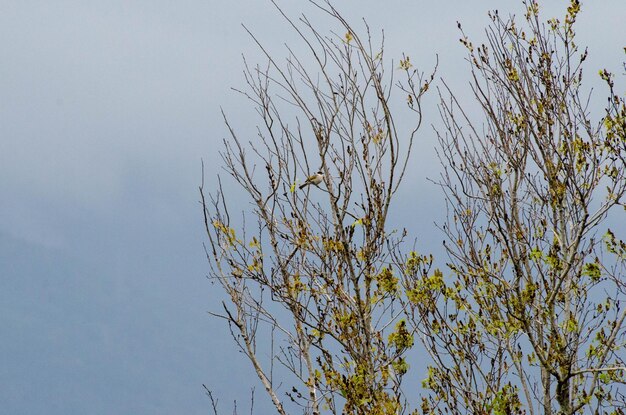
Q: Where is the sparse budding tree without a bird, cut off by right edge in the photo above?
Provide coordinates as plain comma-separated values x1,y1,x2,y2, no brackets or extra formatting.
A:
405,0,626,414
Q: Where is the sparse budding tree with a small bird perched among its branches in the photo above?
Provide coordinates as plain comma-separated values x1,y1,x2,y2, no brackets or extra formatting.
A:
200,2,434,414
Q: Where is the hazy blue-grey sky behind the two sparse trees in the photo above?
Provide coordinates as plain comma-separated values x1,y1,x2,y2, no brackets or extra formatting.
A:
0,0,626,415
